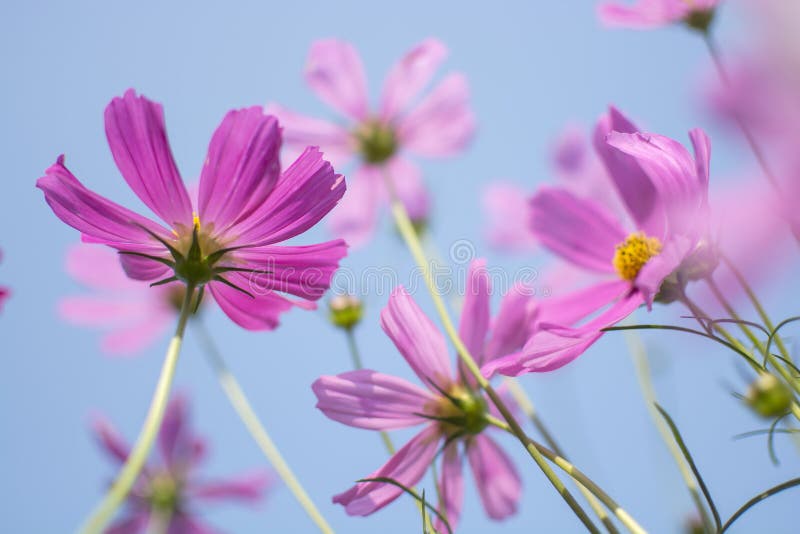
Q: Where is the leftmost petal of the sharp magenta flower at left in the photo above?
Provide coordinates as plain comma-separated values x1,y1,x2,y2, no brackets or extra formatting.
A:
36,156,170,250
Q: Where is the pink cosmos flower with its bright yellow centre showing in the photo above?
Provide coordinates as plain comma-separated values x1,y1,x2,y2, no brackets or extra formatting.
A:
483,108,715,375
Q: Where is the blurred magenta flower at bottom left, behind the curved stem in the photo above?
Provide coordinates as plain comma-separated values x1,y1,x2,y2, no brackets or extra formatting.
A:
93,396,271,534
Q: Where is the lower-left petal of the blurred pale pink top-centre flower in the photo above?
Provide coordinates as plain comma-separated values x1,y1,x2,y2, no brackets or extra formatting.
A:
330,165,386,247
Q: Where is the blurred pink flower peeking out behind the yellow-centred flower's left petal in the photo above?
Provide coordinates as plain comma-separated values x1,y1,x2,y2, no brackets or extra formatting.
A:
483,126,619,252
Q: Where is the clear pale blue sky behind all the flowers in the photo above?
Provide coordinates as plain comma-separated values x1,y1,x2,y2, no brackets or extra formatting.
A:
0,0,800,533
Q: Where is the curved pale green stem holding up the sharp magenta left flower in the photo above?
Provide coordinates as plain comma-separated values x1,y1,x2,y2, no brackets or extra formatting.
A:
80,284,195,534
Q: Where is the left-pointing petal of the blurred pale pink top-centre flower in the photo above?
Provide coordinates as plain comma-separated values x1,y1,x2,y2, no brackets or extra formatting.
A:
264,104,356,167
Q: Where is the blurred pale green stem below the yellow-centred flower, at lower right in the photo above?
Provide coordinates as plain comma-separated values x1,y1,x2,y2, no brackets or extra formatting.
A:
624,322,715,532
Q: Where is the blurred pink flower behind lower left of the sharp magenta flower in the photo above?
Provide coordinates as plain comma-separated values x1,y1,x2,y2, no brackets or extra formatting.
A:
58,244,200,356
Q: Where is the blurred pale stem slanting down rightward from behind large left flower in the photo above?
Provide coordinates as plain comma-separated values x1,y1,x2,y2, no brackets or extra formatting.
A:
196,318,333,534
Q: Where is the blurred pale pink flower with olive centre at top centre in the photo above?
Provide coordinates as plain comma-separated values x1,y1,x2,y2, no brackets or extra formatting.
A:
267,39,475,245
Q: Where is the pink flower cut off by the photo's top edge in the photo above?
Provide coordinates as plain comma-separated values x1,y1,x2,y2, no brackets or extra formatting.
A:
597,0,721,30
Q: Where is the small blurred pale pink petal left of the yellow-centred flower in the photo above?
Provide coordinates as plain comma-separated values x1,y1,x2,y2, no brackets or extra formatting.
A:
482,182,536,252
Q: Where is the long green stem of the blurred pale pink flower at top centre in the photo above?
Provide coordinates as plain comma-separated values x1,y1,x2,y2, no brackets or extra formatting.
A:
385,175,608,532
